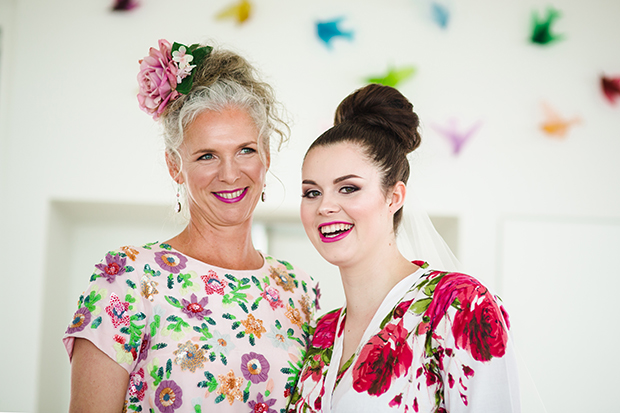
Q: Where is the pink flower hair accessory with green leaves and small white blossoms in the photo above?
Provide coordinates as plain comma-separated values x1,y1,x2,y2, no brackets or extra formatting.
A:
138,39,213,120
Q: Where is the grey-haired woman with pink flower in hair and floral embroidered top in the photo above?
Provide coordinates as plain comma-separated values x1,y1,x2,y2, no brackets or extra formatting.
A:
63,40,316,413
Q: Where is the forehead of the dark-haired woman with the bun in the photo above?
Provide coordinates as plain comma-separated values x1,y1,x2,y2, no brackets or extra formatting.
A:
302,142,379,181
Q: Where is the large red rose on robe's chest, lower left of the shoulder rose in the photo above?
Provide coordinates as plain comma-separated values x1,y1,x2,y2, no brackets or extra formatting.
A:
353,320,413,396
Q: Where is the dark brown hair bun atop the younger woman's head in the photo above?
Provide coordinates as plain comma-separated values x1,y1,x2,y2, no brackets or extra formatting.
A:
334,83,421,153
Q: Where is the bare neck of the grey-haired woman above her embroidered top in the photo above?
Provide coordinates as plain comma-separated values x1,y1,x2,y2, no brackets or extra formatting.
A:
167,216,263,270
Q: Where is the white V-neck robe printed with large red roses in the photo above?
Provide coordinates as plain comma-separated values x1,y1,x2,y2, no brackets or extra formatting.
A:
289,261,520,413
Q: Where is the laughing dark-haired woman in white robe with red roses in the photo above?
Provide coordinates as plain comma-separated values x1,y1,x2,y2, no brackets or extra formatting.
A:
290,84,519,413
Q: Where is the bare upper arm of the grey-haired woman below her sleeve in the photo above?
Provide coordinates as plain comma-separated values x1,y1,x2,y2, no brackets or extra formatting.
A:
69,338,129,413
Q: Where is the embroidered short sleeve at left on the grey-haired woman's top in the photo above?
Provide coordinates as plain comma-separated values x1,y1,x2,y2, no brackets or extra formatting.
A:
63,250,147,373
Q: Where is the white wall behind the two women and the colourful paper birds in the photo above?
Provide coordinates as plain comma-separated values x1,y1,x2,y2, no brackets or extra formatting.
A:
0,0,620,412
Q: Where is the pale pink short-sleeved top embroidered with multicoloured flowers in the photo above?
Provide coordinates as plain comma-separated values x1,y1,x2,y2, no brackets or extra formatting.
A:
63,243,317,413
